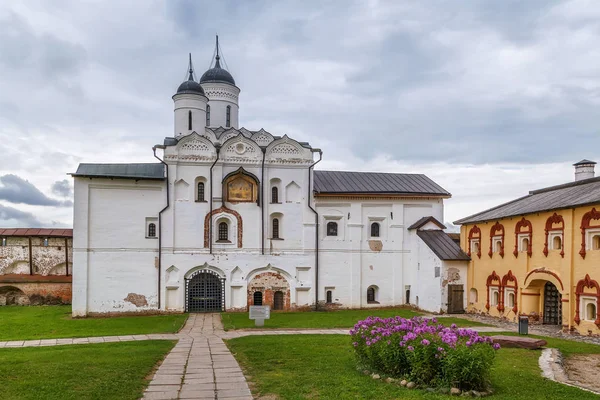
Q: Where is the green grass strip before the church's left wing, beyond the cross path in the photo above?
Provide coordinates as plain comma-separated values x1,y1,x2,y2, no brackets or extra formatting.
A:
0,306,187,340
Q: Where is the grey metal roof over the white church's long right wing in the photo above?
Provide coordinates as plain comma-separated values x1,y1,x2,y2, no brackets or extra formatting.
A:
314,171,451,197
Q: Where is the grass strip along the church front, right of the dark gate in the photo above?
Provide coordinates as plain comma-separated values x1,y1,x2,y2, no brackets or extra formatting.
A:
221,308,487,331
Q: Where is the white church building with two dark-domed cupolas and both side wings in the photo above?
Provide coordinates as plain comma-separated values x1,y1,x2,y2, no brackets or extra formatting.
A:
72,39,469,316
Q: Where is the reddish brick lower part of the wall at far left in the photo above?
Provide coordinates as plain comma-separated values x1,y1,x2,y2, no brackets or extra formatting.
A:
0,274,72,306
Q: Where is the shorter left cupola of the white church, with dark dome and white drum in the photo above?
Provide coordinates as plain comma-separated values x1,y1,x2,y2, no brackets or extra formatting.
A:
173,54,208,137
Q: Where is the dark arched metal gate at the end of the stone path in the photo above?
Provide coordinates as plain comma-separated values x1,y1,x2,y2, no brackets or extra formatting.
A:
185,269,225,312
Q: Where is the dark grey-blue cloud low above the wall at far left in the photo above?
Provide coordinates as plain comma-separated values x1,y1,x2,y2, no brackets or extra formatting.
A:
0,174,73,207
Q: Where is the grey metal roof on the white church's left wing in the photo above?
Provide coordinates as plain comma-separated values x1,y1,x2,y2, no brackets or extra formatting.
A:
71,163,165,180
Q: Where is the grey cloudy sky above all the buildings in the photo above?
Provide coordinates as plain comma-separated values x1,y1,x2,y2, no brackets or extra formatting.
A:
0,0,600,227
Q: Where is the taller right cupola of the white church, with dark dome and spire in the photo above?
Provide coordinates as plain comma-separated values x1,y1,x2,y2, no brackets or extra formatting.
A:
200,36,240,128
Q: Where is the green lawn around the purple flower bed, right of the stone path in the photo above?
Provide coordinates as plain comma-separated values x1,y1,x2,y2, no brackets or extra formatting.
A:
227,335,600,400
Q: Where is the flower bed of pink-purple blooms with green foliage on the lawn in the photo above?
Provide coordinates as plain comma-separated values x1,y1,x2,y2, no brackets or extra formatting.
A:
350,317,500,390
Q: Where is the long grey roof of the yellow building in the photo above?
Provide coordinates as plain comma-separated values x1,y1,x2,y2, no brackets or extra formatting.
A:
454,177,600,224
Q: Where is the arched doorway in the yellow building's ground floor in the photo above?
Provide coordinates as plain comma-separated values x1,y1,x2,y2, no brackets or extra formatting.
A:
521,268,565,325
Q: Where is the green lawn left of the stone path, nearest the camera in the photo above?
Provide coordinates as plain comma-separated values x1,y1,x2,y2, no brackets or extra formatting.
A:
0,340,174,400
